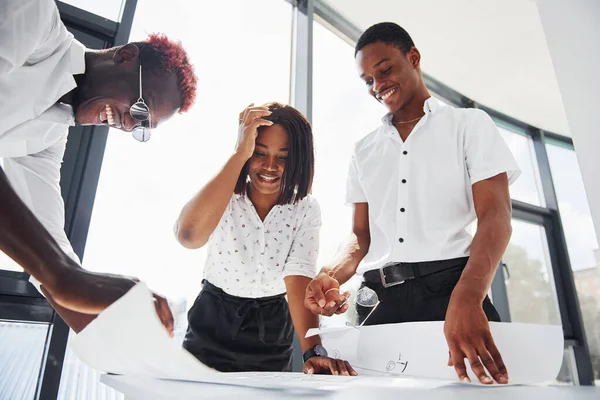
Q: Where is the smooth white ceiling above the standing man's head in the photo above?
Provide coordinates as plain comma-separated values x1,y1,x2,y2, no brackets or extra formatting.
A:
325,0,570,136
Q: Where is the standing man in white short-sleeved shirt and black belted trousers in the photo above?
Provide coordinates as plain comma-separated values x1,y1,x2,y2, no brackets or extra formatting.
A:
305,23,519,384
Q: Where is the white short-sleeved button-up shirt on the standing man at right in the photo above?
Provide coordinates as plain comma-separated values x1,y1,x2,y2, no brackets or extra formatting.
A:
346,97,520,274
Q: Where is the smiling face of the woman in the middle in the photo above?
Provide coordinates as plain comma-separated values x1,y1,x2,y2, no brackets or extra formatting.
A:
248,124,288,199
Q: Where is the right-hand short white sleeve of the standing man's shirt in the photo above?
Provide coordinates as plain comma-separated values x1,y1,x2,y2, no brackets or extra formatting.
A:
465,110,521,185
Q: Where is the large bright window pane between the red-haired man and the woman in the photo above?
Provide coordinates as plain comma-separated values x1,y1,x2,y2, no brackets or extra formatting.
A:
61,0,292,393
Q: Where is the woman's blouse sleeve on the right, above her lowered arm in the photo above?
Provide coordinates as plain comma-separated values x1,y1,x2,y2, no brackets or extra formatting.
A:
283,197,321,278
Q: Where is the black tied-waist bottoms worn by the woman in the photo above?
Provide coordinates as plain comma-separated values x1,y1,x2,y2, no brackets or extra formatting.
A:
183,281,294,372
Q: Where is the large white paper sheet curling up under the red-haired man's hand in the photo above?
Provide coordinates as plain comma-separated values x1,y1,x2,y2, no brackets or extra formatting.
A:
70,283,445,394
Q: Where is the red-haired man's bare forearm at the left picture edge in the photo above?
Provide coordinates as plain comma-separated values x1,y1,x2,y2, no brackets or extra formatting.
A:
0,168,77,290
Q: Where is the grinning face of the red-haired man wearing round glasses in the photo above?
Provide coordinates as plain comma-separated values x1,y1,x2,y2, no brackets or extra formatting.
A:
73,45,181,132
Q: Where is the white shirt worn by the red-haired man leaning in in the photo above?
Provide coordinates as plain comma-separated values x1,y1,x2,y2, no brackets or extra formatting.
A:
0,0,85,262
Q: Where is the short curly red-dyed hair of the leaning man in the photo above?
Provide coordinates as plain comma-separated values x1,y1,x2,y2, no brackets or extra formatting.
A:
134,33,198,113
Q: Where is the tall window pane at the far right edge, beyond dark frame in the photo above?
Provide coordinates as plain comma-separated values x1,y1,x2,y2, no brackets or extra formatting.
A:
546,144,600,380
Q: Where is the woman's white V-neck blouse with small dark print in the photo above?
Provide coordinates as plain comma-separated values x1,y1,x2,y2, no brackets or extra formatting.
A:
204,194,321,298
